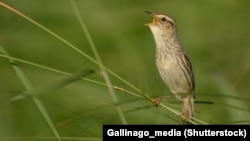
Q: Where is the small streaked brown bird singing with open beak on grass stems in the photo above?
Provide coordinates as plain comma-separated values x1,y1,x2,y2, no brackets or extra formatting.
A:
145,11,195,124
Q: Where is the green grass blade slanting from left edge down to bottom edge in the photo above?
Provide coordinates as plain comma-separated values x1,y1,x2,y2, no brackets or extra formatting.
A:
0,46,61,141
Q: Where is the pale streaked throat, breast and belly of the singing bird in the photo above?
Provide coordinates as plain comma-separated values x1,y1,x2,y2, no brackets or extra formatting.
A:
150,26,194,100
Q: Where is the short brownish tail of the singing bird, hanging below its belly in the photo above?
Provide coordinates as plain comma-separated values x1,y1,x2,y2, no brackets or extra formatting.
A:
182,95,194,122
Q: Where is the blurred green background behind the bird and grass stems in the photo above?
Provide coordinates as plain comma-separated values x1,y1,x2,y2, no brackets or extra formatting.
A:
0,0,250,140
